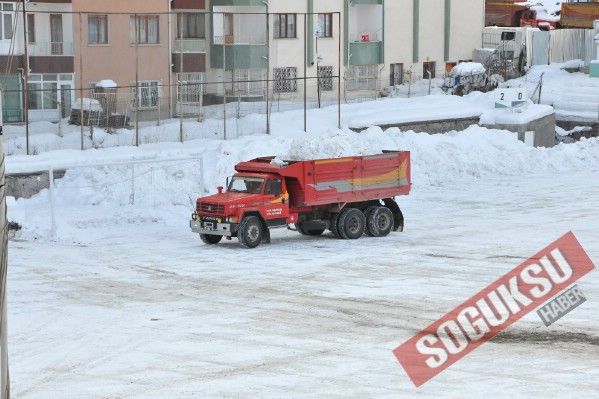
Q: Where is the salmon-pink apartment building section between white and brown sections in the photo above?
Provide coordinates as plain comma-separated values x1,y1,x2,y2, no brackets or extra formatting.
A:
73,0,171,119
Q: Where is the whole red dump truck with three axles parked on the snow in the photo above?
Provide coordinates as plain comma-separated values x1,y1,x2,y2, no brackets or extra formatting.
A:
190,151,411,248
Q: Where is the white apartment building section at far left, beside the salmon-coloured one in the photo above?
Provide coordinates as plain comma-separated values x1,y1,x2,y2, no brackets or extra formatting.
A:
0,0,74,122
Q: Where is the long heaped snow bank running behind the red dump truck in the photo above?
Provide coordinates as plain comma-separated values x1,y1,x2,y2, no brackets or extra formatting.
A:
8,126,599,242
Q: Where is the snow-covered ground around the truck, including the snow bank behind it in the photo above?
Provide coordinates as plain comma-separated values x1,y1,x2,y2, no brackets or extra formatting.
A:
7,121,599,399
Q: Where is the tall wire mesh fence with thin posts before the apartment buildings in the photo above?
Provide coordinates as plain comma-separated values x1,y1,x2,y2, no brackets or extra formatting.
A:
0,6,460,154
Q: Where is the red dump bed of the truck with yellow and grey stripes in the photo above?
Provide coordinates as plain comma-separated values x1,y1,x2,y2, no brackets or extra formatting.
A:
235,151,411,207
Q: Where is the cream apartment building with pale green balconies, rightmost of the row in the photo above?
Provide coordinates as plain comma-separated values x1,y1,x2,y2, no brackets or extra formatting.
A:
207,0,484,100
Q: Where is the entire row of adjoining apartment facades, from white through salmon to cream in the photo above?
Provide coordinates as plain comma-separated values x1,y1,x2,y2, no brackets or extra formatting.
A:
0,0,485,121
